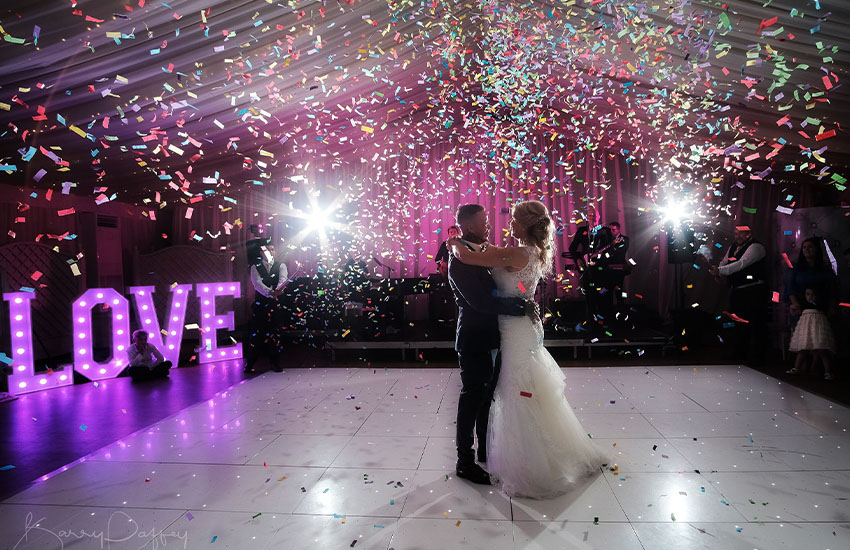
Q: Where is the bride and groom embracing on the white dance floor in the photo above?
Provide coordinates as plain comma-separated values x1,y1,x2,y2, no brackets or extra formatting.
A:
448,201,608,498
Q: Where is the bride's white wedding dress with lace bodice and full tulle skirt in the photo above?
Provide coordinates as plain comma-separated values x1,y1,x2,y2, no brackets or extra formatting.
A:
487,253,609,498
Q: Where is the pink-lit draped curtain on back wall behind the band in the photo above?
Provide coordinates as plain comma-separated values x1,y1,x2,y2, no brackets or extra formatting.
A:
166,139,716,320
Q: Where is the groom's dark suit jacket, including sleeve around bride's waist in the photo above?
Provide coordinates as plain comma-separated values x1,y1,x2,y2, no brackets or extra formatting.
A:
449,243,525,352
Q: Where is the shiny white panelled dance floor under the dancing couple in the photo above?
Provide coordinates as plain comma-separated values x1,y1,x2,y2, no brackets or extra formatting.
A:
0,366,850,550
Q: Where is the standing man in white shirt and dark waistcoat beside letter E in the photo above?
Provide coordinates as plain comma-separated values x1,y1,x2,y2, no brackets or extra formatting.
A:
245,244,289,372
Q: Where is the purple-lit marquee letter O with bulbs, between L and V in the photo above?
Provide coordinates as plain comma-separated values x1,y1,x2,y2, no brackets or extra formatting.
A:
71,288,130,380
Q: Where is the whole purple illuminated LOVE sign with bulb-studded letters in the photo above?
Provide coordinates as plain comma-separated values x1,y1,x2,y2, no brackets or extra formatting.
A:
3,282,242,395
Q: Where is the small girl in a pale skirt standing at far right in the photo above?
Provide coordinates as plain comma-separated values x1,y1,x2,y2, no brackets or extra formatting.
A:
786,288,835,380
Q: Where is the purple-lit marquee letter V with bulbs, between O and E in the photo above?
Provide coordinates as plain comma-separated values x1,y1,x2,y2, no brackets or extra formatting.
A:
130,285,192,365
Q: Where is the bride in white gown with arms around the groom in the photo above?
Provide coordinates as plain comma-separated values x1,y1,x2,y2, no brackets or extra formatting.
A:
450,201,609,498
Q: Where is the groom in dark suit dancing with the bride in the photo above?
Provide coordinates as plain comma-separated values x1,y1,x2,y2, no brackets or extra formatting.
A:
449,204,537,485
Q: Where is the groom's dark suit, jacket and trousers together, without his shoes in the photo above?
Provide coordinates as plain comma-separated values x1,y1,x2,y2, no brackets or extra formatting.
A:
449,255,525,465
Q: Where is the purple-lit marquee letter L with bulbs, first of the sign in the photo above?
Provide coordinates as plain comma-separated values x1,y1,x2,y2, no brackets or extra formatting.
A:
3,292,74,395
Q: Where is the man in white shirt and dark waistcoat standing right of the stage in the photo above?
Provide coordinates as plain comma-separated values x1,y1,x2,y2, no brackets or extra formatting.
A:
708,225,769,366
